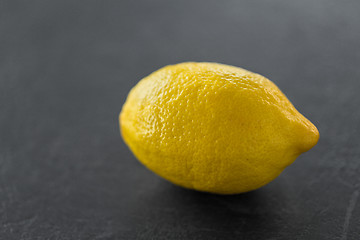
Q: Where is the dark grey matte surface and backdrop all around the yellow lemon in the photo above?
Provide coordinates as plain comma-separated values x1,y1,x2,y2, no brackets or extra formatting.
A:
0,0,360,240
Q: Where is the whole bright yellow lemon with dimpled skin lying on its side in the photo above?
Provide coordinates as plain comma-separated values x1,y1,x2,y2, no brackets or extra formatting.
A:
119,62,319,194
